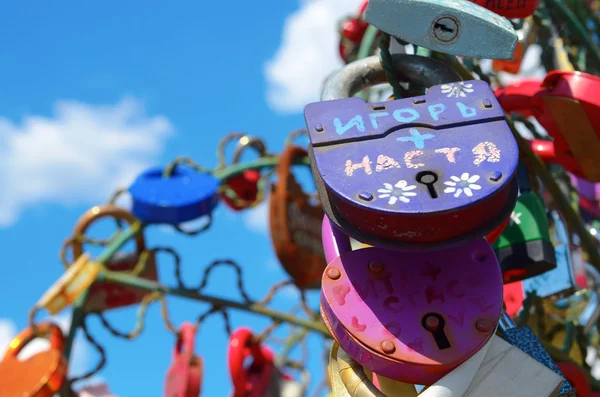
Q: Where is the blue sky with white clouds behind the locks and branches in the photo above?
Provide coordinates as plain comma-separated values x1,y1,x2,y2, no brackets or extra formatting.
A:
0,0,360,397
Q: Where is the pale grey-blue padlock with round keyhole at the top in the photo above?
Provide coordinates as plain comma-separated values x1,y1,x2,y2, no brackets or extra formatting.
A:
365,0,518,59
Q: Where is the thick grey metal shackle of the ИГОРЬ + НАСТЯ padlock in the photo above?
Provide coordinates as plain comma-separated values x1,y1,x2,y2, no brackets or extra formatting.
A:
321,54,462,101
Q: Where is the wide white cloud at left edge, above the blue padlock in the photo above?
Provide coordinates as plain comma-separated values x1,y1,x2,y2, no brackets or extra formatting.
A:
0,97,173,227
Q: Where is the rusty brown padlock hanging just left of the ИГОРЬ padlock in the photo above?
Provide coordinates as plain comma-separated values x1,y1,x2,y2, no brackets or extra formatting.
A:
269,146,327,289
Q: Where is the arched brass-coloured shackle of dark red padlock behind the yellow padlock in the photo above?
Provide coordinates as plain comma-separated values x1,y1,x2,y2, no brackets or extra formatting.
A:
71,204,146,260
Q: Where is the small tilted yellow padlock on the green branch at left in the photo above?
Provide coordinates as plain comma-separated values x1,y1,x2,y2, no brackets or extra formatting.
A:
36,253,102,315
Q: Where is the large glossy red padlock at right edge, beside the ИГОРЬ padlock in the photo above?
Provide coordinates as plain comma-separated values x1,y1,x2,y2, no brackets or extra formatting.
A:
496,70,600,182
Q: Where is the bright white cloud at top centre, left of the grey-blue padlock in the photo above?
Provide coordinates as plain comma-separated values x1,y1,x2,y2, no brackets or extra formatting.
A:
265,0,363,112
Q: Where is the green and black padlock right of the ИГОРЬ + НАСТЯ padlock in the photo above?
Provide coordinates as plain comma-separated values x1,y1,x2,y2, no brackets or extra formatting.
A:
493,162,556,284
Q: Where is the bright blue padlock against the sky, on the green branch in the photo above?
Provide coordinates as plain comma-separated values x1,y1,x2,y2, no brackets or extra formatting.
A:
129,165,220,225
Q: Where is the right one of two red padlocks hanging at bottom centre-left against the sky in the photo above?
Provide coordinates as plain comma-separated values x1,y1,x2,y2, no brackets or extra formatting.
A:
227,328,276,397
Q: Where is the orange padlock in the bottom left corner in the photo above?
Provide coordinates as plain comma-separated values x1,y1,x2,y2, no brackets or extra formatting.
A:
0,322,67,397
